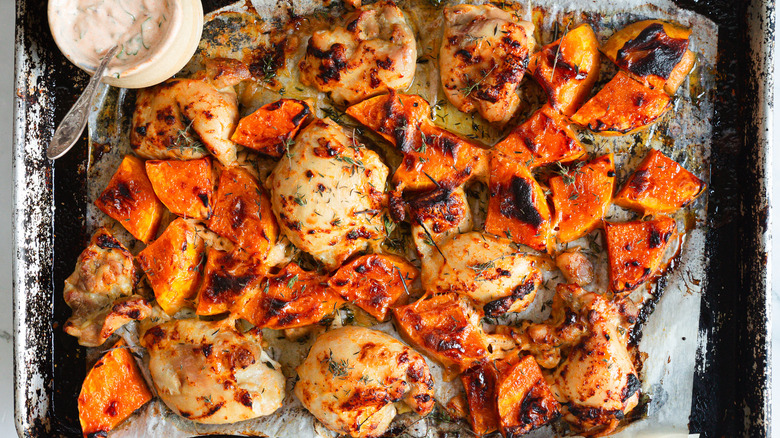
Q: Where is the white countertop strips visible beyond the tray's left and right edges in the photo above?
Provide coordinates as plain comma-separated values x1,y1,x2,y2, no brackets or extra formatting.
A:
0,0,780,437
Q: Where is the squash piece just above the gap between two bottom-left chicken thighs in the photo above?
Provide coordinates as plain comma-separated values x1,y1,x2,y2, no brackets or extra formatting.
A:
237,263,344,330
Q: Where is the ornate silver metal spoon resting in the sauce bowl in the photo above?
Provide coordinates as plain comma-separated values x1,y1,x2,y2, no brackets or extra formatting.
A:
46,46,119,160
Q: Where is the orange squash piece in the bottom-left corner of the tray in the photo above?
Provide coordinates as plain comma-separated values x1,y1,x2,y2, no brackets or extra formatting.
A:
78,340,152,438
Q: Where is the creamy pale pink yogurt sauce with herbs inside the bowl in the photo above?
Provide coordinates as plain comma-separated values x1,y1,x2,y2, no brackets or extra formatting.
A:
49,0,180,77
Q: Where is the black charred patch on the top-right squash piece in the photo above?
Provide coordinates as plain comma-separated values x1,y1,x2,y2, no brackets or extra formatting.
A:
616,23,688,79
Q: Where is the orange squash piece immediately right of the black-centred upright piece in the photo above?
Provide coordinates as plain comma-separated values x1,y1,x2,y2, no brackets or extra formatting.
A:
549,154,615,243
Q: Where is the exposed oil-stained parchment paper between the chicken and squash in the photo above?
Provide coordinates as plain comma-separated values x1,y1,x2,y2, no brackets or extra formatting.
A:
80,0,717,438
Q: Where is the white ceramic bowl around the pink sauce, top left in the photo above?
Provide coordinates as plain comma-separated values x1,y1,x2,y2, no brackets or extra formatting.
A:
48,0,203,88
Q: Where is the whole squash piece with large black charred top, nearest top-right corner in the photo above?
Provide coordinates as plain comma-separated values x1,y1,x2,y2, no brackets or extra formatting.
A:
602,20,696,94
